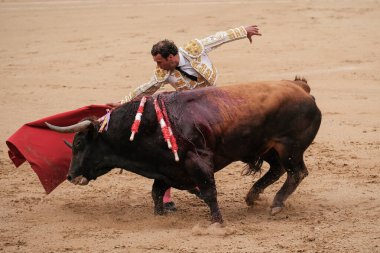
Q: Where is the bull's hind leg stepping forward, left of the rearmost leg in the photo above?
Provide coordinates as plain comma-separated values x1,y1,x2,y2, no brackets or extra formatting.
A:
245,152,285,206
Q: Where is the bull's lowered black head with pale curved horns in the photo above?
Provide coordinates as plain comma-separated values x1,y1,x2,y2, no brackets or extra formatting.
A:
46,120,112,185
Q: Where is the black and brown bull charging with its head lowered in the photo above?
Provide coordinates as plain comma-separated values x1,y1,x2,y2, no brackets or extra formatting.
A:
46,78,321,222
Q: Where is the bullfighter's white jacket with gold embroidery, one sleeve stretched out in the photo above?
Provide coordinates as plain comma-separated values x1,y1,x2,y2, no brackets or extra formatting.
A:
122,26,247,103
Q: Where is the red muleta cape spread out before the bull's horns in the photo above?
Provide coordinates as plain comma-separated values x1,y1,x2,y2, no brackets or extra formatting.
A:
6,105,109,194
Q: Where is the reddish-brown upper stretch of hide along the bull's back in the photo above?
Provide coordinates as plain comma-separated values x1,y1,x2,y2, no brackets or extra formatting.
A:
184,81,315,130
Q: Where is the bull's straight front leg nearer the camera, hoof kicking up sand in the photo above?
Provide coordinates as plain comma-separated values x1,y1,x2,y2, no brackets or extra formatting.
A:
186,150,223,223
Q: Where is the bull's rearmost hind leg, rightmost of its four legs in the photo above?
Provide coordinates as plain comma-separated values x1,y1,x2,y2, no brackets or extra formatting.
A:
271,146,308,215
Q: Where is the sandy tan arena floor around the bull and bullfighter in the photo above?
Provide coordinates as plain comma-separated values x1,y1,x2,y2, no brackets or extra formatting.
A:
0,0,380,253
